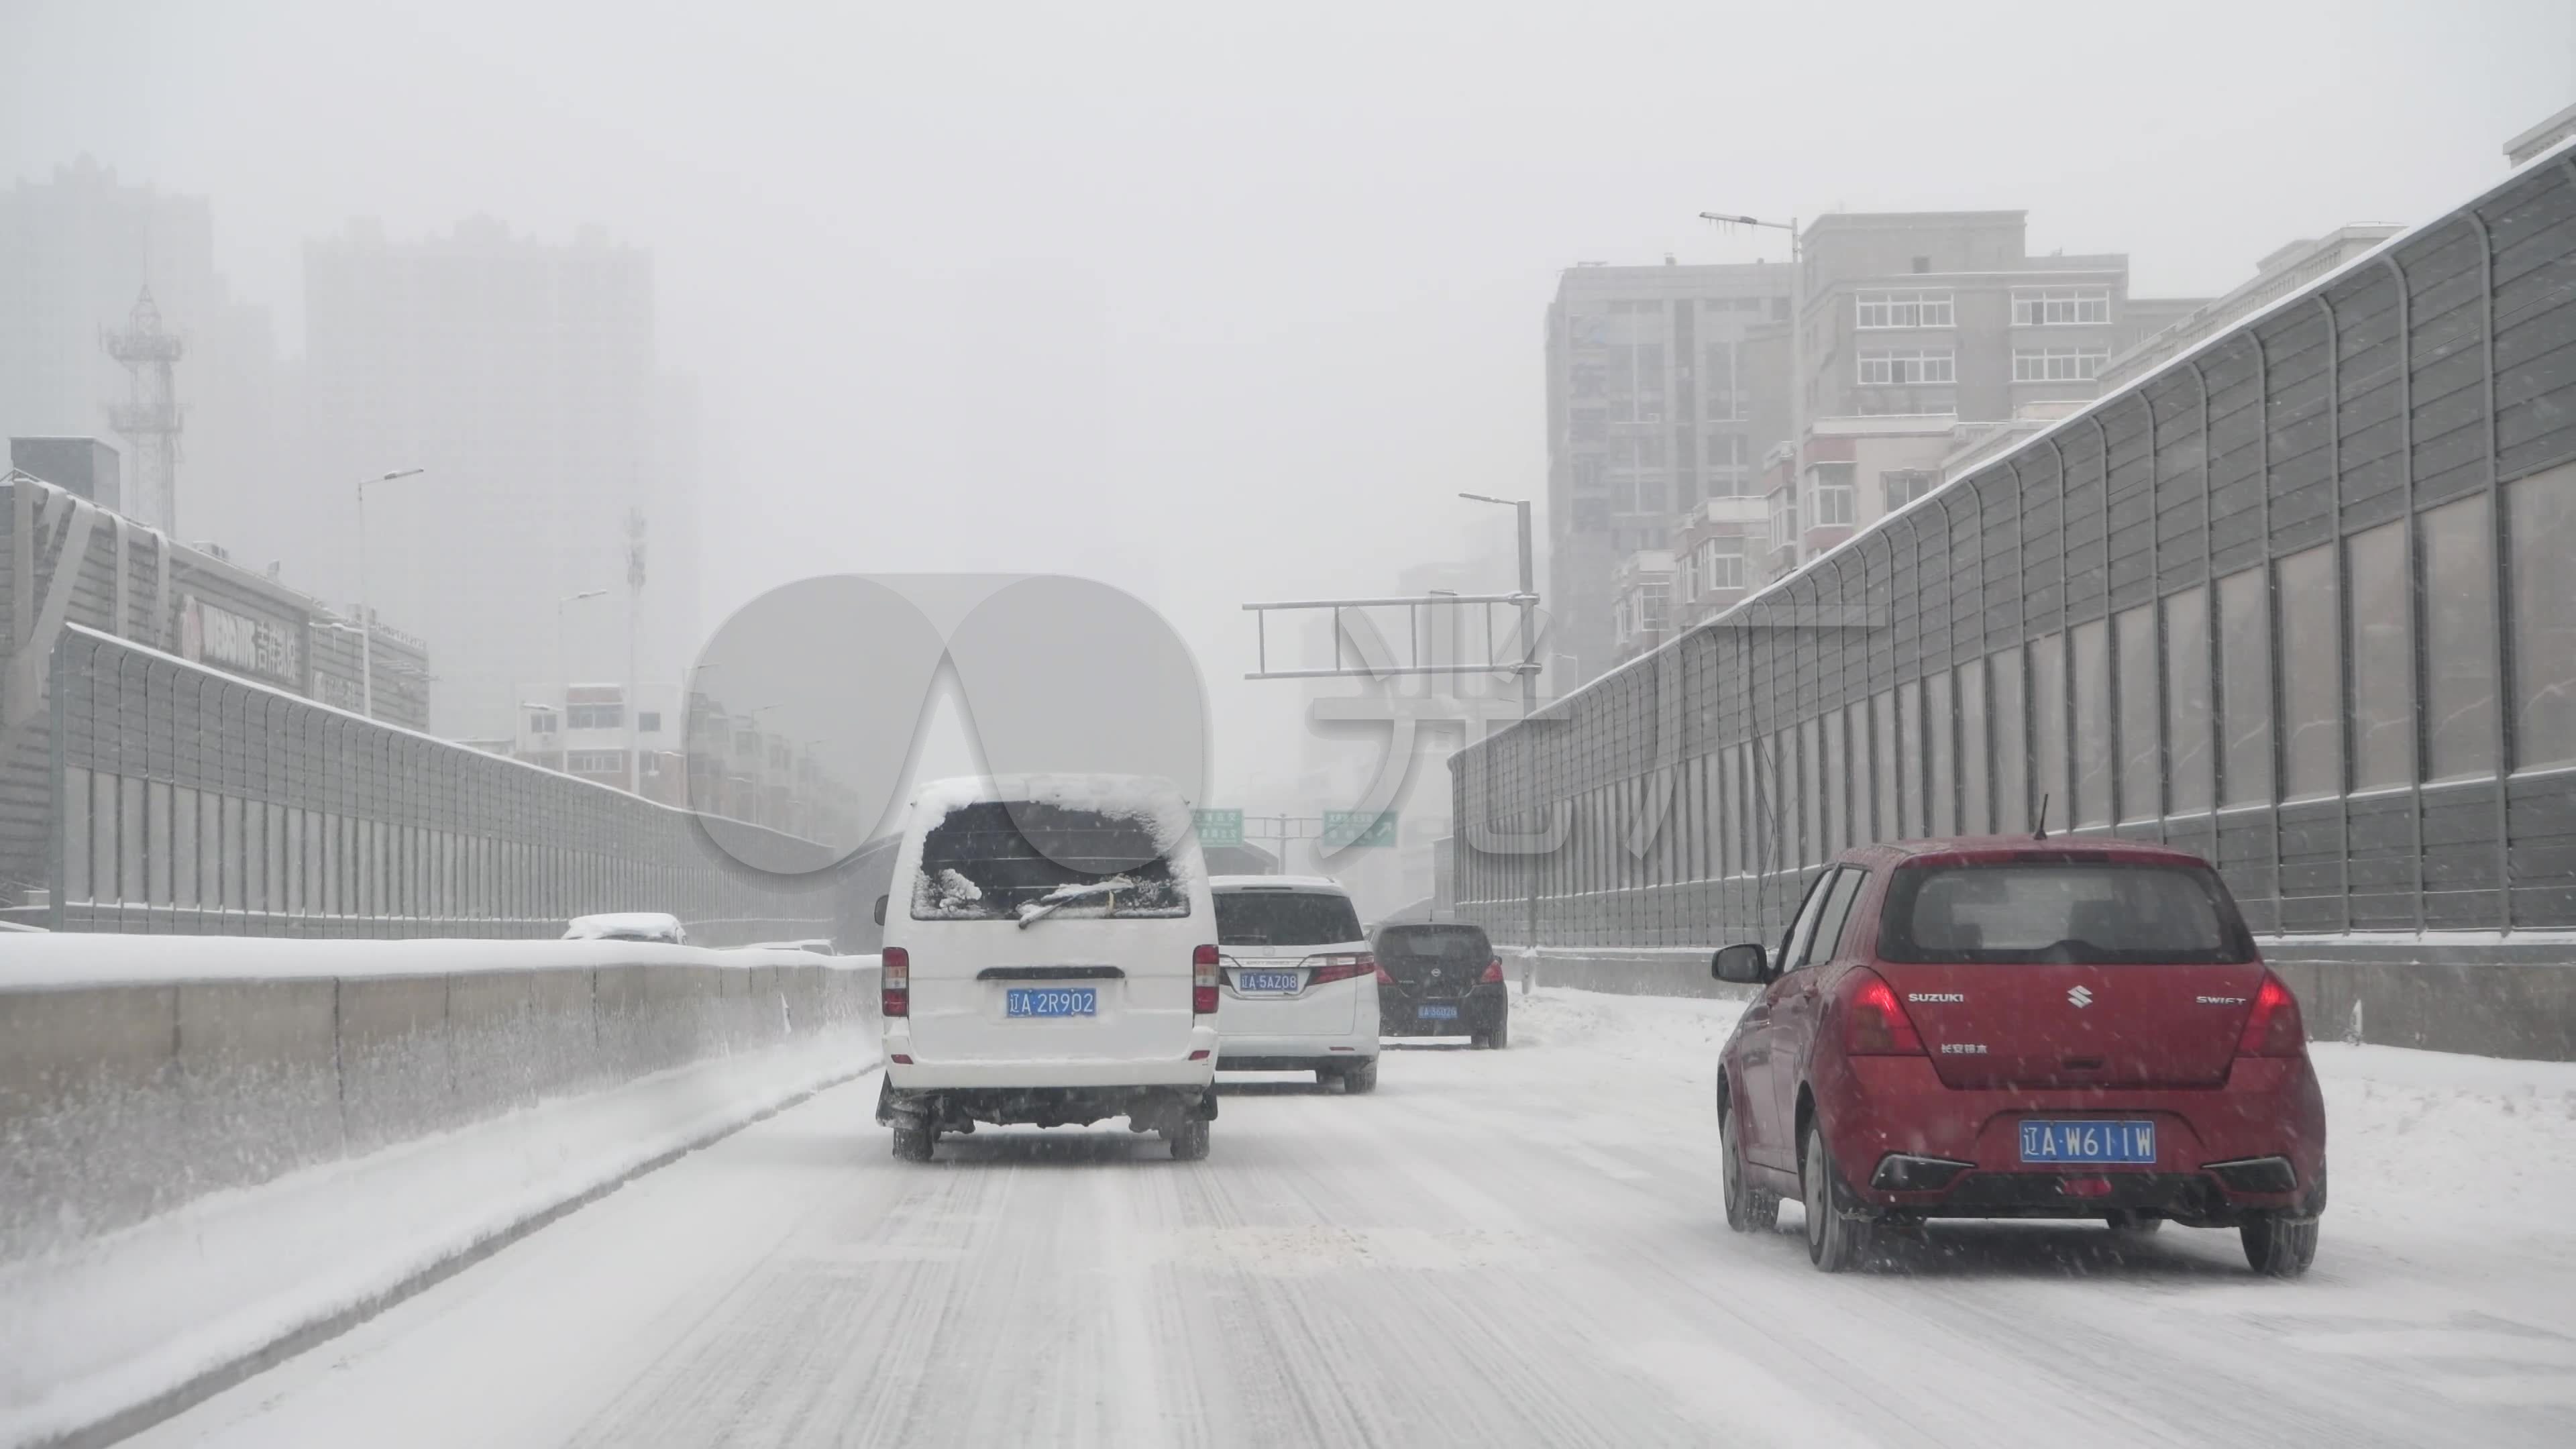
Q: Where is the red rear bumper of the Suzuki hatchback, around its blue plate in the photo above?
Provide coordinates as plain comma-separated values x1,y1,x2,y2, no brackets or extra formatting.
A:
1816,1057,2326,1222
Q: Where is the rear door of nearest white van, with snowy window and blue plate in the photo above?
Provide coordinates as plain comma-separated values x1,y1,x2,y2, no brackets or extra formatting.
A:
899,802,1211,1062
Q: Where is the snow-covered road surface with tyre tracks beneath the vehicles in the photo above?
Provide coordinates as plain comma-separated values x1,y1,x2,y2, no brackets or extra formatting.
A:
139,993,2576,1449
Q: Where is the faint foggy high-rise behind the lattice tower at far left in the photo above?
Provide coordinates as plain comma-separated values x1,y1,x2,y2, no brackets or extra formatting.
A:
0,157,301,546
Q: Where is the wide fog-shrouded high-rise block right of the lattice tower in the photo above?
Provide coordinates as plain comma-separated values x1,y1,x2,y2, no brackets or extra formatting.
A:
301,217,698,735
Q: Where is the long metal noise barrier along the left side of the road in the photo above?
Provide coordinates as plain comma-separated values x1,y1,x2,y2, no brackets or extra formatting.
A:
25,627,843,944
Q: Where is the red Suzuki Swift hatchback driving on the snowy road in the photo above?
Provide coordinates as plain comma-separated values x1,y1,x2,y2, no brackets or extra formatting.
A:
1711,838,2326,1276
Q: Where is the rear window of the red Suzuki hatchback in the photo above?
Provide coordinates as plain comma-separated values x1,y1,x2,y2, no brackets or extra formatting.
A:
1878,861,2254,964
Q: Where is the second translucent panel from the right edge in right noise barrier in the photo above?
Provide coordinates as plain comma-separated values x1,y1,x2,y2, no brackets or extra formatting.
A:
2422,495,2493,779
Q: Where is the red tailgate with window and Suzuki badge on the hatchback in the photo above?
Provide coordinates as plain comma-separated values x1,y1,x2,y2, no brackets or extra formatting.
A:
1873,853,2264,1088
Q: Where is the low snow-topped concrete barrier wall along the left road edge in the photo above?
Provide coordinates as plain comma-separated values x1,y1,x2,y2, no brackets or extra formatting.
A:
0,936,876,1260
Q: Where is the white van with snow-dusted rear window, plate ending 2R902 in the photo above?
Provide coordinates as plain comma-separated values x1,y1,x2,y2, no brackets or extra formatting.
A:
876,776,1218,1163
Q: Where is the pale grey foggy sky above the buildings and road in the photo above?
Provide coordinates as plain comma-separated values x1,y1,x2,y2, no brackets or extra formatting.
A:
0,0,2576,807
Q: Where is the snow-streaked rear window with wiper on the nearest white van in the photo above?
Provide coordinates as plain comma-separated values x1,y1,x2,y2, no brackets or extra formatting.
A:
912,799,1190,920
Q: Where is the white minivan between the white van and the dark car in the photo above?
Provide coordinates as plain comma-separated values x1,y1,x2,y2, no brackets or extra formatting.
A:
1211,877,1378,1091
